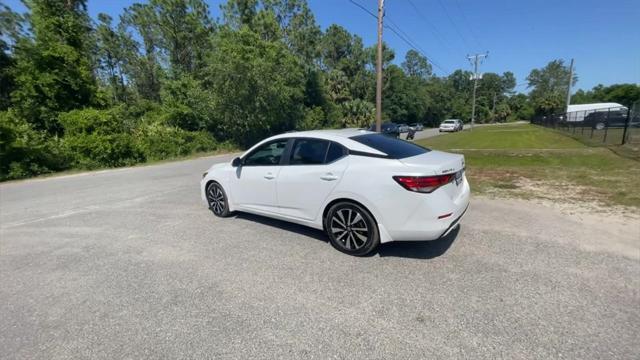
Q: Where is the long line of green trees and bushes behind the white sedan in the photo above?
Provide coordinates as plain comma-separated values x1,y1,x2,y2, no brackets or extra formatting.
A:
0,0,639,180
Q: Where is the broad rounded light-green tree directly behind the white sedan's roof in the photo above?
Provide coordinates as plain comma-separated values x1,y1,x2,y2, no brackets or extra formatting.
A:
204,28,304,146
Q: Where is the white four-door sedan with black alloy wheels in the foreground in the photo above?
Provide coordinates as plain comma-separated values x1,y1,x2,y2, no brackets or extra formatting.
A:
200,129,470,256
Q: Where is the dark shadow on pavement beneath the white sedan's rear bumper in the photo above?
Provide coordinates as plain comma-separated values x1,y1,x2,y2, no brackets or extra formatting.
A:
378,225,460,259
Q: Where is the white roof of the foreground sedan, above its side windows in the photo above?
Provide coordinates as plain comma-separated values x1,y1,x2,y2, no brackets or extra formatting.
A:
243,128,386,156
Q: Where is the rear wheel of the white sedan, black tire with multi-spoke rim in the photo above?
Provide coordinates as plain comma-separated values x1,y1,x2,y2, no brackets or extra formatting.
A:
324,201,380,256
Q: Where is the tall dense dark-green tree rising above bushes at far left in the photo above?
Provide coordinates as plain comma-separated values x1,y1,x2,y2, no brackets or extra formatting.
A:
11,0,97,135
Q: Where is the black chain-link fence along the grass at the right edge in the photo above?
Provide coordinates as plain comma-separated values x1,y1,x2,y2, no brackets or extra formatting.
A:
531,101,640,145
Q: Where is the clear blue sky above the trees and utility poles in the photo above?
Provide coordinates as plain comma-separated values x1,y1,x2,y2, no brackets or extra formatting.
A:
5,0,640,91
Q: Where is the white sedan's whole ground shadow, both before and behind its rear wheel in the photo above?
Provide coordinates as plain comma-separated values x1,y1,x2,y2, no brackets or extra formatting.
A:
235,212,460,259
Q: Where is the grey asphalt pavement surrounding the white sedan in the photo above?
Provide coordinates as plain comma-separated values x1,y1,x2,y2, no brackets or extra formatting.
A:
0,156,640,359
